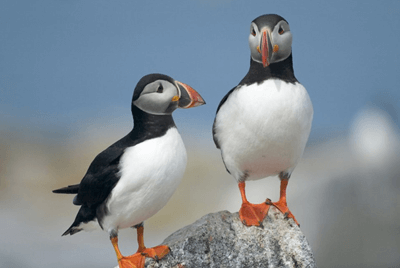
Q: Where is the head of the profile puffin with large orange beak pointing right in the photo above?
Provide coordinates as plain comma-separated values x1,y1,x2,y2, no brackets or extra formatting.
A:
132,74,205,115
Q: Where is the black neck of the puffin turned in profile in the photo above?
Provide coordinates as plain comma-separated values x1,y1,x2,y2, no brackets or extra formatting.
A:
130,105,175,139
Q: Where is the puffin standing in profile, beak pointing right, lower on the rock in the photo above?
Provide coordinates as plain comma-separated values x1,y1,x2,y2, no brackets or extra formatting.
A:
53,73,205,268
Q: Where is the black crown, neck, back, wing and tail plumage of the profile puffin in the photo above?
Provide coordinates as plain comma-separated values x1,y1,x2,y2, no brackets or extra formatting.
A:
53,75,175,235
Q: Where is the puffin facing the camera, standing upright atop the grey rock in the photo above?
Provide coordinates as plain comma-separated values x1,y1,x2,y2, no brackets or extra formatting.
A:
212,14,314,226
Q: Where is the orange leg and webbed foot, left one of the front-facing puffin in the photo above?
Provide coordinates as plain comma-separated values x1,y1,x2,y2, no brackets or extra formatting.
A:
238,181,270,226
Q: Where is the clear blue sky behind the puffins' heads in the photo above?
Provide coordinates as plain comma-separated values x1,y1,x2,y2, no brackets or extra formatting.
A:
0,0,400,144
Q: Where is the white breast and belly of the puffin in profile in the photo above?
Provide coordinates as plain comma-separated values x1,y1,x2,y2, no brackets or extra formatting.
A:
103,128,187,231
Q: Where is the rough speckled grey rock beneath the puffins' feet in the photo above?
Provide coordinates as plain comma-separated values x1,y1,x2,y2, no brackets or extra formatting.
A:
145,207,316,268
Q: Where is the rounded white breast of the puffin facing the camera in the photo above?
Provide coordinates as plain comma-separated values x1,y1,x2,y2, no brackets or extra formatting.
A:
215,79,313,180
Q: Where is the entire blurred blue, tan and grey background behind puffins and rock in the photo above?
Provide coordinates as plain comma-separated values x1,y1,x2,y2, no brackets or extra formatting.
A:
0,0,400,268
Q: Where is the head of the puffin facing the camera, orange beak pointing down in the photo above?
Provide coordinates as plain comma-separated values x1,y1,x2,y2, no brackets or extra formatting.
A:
249,14,292,67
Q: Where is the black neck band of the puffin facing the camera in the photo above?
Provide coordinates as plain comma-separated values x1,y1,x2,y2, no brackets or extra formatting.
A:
239,54,298,85
